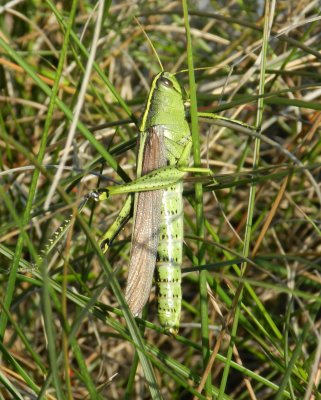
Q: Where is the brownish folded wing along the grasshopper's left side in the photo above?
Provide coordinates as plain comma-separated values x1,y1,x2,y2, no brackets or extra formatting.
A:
126,125,166,316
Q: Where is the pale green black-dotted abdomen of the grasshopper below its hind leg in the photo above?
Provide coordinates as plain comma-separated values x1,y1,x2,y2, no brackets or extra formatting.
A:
156,182,183,334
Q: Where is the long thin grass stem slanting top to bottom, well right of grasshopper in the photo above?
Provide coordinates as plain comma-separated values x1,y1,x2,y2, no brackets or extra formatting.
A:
218,0,274,400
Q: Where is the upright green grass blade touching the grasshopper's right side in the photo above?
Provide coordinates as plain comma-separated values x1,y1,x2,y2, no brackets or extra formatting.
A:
182,0,211,394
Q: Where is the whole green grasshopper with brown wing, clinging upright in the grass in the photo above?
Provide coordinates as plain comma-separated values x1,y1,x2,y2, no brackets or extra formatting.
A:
91,72,192,334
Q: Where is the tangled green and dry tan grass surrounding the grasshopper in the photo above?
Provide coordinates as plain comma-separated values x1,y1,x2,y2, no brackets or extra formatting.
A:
0,0,321,400
